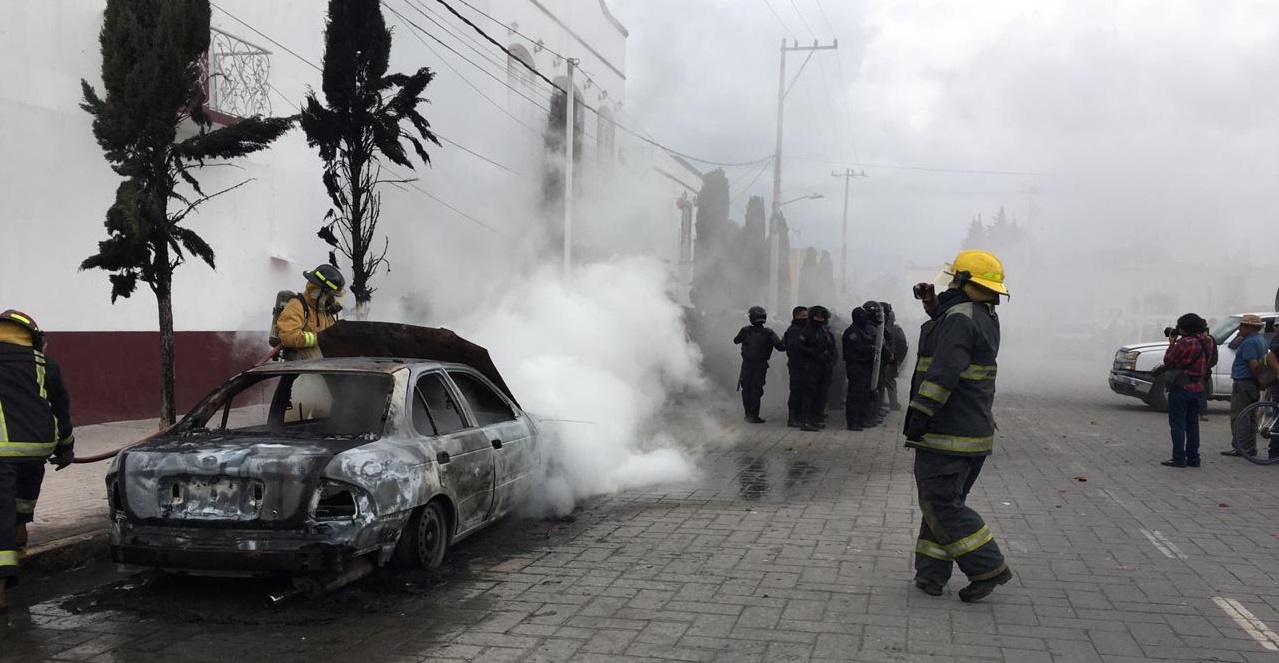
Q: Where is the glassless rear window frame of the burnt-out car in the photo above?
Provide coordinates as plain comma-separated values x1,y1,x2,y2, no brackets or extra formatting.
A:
178,369,395,440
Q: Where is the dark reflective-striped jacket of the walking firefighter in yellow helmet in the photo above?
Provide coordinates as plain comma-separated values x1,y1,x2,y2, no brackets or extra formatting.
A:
906,291,999,456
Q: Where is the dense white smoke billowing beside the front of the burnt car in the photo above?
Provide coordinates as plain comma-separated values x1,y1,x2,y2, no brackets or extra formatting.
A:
450,257,703,513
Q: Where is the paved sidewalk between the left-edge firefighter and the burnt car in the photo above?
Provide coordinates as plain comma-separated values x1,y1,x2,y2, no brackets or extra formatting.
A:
27,420,156,553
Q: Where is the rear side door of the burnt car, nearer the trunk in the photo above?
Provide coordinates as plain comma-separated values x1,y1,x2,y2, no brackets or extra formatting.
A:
411,371,495,532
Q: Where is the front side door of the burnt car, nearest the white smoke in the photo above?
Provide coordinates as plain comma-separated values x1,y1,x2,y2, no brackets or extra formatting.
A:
448,369,536,517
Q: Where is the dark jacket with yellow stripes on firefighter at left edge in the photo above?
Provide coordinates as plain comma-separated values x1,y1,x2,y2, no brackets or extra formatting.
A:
0,325,75,462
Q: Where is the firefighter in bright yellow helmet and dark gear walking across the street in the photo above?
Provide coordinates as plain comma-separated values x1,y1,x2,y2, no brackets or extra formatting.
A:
904,251,1013,603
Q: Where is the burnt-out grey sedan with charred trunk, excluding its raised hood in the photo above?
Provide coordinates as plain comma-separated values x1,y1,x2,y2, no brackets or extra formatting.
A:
106,357,542,575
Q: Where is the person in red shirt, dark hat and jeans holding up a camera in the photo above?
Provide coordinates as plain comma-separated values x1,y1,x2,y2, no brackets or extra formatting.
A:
1159,314,1216,467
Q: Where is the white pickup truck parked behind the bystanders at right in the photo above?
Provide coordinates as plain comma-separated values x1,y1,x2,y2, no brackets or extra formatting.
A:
1110,311,1279,411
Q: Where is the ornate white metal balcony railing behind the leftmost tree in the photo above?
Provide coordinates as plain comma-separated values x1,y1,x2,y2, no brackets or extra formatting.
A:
203,28,271,124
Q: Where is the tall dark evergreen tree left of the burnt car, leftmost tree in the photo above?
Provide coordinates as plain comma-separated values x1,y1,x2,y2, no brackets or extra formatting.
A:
81,0,293,424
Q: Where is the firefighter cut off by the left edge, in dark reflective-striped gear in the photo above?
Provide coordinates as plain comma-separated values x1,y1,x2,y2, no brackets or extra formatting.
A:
0,310,75,614
